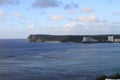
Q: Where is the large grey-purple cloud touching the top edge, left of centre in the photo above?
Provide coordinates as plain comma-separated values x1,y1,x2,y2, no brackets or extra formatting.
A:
33,0,59,9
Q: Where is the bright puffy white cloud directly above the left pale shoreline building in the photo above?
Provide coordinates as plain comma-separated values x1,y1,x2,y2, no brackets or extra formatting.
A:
76,15,99,22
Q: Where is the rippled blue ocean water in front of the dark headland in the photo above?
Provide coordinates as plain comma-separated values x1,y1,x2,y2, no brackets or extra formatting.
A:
0,39,120,80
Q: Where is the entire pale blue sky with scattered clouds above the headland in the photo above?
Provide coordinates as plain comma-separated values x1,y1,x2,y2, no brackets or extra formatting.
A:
0,0,120,39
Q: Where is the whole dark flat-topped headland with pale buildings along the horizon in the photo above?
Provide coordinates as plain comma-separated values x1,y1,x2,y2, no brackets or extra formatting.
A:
28,34,120,43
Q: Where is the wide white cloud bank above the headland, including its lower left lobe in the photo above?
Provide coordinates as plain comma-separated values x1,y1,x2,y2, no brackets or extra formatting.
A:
64,15,101,32
